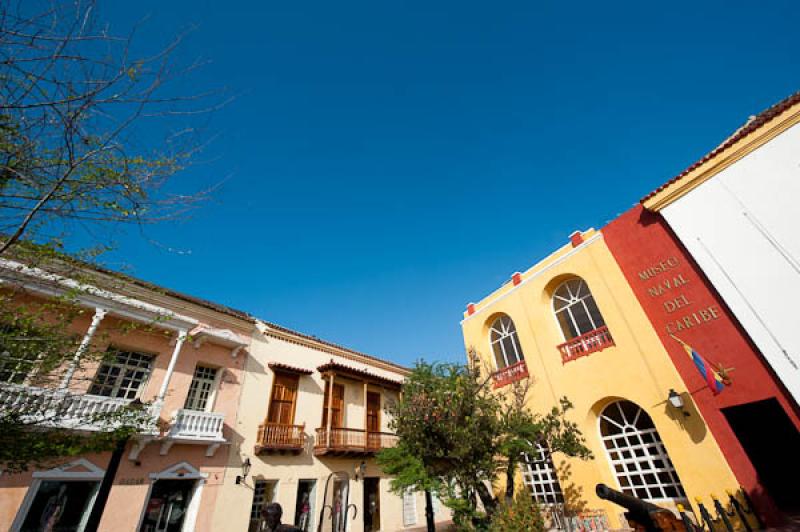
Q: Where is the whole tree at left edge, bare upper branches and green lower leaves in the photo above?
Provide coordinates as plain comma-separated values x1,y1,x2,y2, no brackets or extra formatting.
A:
0,0,224,471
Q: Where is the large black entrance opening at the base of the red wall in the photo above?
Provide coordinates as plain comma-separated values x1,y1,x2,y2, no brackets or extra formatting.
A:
722,399,800,513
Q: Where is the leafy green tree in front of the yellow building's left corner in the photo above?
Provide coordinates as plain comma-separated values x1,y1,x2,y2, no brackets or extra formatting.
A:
378,350,590,528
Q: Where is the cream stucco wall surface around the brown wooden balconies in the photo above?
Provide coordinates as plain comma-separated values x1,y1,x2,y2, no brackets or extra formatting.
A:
213,333,448,532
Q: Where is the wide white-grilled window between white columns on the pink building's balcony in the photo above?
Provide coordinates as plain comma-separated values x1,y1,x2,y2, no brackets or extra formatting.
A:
89,351,154,399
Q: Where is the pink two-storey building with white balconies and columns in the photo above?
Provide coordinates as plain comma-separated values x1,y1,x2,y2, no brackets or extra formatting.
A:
0,260,254,532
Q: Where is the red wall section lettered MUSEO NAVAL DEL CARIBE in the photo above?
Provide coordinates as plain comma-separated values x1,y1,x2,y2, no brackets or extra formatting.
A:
602,205,800,524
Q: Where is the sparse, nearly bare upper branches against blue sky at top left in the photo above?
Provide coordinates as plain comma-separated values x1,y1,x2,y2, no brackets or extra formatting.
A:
0,0,222,254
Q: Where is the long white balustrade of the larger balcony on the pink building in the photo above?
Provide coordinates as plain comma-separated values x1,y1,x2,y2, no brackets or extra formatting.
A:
0,384,155,431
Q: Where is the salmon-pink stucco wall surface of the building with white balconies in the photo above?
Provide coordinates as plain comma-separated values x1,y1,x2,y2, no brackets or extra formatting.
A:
0,290,246,532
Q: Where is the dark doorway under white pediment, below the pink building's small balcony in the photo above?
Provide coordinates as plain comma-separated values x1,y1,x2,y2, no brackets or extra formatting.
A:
139,480,195,532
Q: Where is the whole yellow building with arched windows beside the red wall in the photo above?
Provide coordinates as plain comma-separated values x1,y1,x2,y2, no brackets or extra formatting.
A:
462,230,739,528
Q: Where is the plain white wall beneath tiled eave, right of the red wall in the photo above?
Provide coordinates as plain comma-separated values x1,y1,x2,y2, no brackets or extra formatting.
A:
662,121,800,402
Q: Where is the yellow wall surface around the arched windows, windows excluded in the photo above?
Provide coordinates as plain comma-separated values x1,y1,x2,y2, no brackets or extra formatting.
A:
462,231,738,526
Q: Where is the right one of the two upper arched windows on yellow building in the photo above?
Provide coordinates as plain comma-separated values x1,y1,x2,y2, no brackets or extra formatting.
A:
553,278,605,340
